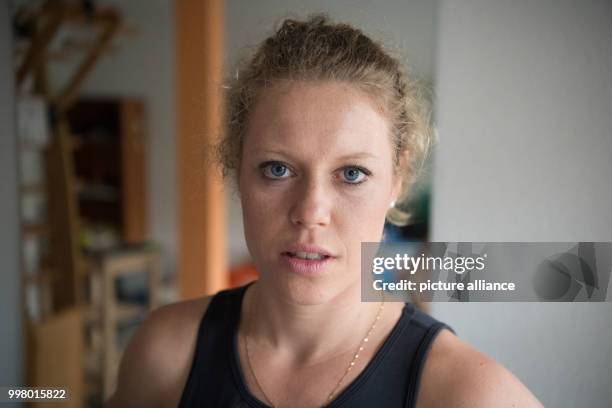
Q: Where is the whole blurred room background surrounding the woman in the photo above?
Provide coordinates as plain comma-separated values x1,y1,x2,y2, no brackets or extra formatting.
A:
0,0,612,407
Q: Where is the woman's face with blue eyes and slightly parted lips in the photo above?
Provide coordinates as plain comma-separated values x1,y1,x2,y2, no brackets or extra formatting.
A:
239,82,400,304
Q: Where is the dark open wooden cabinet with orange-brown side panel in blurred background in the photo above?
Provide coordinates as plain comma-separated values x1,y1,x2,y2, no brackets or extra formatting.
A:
67,97,148,247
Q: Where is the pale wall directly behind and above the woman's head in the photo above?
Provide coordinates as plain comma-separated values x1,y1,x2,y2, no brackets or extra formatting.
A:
226,0,436,265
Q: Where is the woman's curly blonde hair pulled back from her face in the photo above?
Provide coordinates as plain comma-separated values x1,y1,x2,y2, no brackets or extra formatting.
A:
216,14,434,226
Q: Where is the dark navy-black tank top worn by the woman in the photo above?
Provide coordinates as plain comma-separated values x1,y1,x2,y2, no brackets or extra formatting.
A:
179,284,452,408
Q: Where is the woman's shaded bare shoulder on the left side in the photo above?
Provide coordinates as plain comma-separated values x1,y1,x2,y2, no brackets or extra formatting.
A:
106,296,211,407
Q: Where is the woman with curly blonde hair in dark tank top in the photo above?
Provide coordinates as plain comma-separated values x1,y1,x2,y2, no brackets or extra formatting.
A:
110,16,540,407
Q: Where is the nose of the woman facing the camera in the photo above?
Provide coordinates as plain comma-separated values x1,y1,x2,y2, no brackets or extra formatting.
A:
289,175,331,229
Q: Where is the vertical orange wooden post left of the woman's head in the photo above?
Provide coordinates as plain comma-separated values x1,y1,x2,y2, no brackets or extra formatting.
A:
175,0,228,299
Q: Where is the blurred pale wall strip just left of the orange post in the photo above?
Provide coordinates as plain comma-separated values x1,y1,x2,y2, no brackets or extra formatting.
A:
53,0,178,278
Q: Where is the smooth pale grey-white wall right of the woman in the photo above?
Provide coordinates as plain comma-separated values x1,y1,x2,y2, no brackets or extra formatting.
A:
432,0,612,407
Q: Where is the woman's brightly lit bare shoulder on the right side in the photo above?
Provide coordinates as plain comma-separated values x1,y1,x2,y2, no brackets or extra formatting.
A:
417,330,542,408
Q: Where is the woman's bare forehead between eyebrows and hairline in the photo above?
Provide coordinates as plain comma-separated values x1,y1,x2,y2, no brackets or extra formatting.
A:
245,81,390,157
